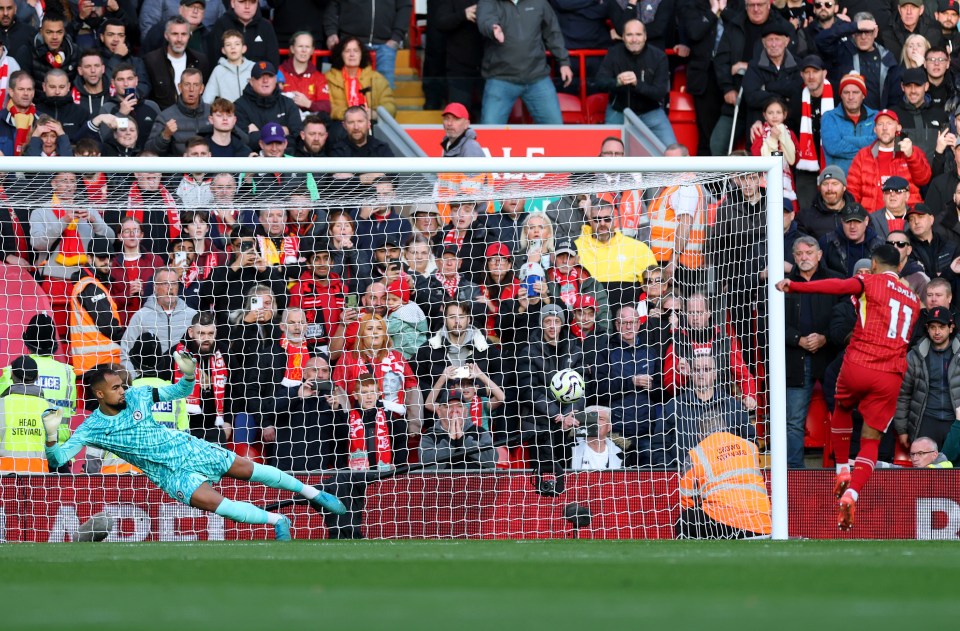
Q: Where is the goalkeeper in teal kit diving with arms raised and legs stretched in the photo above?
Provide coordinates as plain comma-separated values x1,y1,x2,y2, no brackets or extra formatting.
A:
43,353,346,541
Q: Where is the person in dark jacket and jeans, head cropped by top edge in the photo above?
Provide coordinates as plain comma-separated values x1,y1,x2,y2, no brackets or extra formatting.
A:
323,0,412,91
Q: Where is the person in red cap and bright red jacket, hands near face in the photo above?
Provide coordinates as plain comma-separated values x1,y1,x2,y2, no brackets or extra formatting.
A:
847,110,932,212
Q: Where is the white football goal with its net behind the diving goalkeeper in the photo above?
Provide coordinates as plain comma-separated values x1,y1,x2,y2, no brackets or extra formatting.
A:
0,158,786,541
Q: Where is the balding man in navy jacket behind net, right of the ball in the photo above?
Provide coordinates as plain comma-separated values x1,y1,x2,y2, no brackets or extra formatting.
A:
596,307,669,467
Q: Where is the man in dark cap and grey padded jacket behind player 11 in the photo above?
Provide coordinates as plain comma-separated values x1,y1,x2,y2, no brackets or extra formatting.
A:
893,307,960,456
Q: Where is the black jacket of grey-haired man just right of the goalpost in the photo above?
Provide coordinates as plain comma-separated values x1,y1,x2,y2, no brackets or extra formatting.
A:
785,265,844,388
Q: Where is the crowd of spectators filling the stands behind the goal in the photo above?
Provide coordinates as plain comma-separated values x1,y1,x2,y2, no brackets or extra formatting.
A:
0,0,960,494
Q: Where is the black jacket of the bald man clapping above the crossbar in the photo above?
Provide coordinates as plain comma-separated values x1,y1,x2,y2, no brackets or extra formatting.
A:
596,42,670,114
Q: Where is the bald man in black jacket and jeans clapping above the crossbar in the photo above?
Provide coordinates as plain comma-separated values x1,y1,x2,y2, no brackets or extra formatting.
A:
596,20,677,146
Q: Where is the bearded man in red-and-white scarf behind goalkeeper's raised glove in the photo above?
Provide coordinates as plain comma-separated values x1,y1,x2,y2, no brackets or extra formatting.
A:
176,312,233,443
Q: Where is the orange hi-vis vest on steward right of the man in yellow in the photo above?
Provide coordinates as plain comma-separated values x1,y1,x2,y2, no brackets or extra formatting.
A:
648,184,707,269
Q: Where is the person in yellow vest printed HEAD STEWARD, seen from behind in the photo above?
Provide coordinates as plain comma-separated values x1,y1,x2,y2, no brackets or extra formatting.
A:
0,355,51,474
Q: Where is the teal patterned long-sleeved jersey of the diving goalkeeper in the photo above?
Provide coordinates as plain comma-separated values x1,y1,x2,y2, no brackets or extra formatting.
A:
46,379,202,483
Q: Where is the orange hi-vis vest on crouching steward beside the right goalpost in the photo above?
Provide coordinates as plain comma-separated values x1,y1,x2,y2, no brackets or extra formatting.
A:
680,432,771,535
